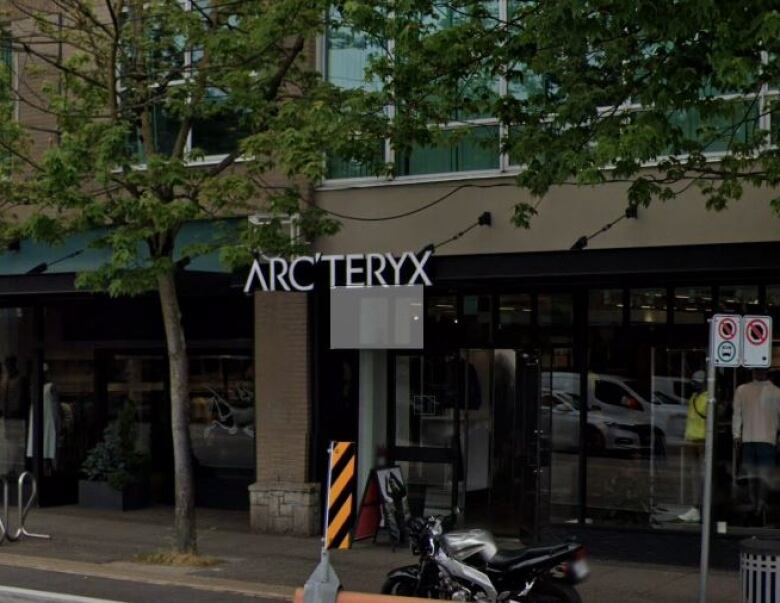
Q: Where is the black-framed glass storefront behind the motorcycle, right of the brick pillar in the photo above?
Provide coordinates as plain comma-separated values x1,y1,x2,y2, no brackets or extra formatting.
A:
315,243,780,548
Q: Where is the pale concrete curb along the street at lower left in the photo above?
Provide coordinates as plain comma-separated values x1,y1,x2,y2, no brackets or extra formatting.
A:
0,553,295,603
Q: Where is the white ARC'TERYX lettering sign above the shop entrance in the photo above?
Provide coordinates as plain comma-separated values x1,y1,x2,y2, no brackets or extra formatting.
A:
244,251,431,293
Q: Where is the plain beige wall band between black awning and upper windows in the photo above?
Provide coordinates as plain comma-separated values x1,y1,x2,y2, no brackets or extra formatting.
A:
317,177,780,255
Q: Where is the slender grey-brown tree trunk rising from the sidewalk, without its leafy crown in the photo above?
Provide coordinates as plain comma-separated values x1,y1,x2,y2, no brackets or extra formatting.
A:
157,270,197,553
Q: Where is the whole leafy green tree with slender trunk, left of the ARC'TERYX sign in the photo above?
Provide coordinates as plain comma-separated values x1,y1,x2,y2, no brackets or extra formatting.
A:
0,0,381,551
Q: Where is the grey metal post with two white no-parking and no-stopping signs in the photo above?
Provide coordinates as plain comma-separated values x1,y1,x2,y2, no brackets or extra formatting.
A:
699,314,772,603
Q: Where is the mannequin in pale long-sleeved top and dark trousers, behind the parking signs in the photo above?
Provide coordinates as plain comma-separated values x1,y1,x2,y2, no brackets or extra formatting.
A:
732,369,780,517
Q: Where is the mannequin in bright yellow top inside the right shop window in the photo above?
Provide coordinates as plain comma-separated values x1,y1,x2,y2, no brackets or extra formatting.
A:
677,371,707,523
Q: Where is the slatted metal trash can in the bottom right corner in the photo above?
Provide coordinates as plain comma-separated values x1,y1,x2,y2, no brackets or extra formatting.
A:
739,538,780,603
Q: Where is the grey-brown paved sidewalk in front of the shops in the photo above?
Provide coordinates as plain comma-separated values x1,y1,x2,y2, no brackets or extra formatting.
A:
0,507,738,603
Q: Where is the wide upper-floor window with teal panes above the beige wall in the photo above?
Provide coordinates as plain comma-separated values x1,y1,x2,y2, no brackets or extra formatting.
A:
322,0,780,179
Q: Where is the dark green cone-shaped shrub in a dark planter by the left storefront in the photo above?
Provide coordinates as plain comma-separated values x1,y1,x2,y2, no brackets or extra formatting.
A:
79,401,149,511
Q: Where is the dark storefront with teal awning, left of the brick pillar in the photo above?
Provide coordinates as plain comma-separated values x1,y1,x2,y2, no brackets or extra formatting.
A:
0,227,256,508
